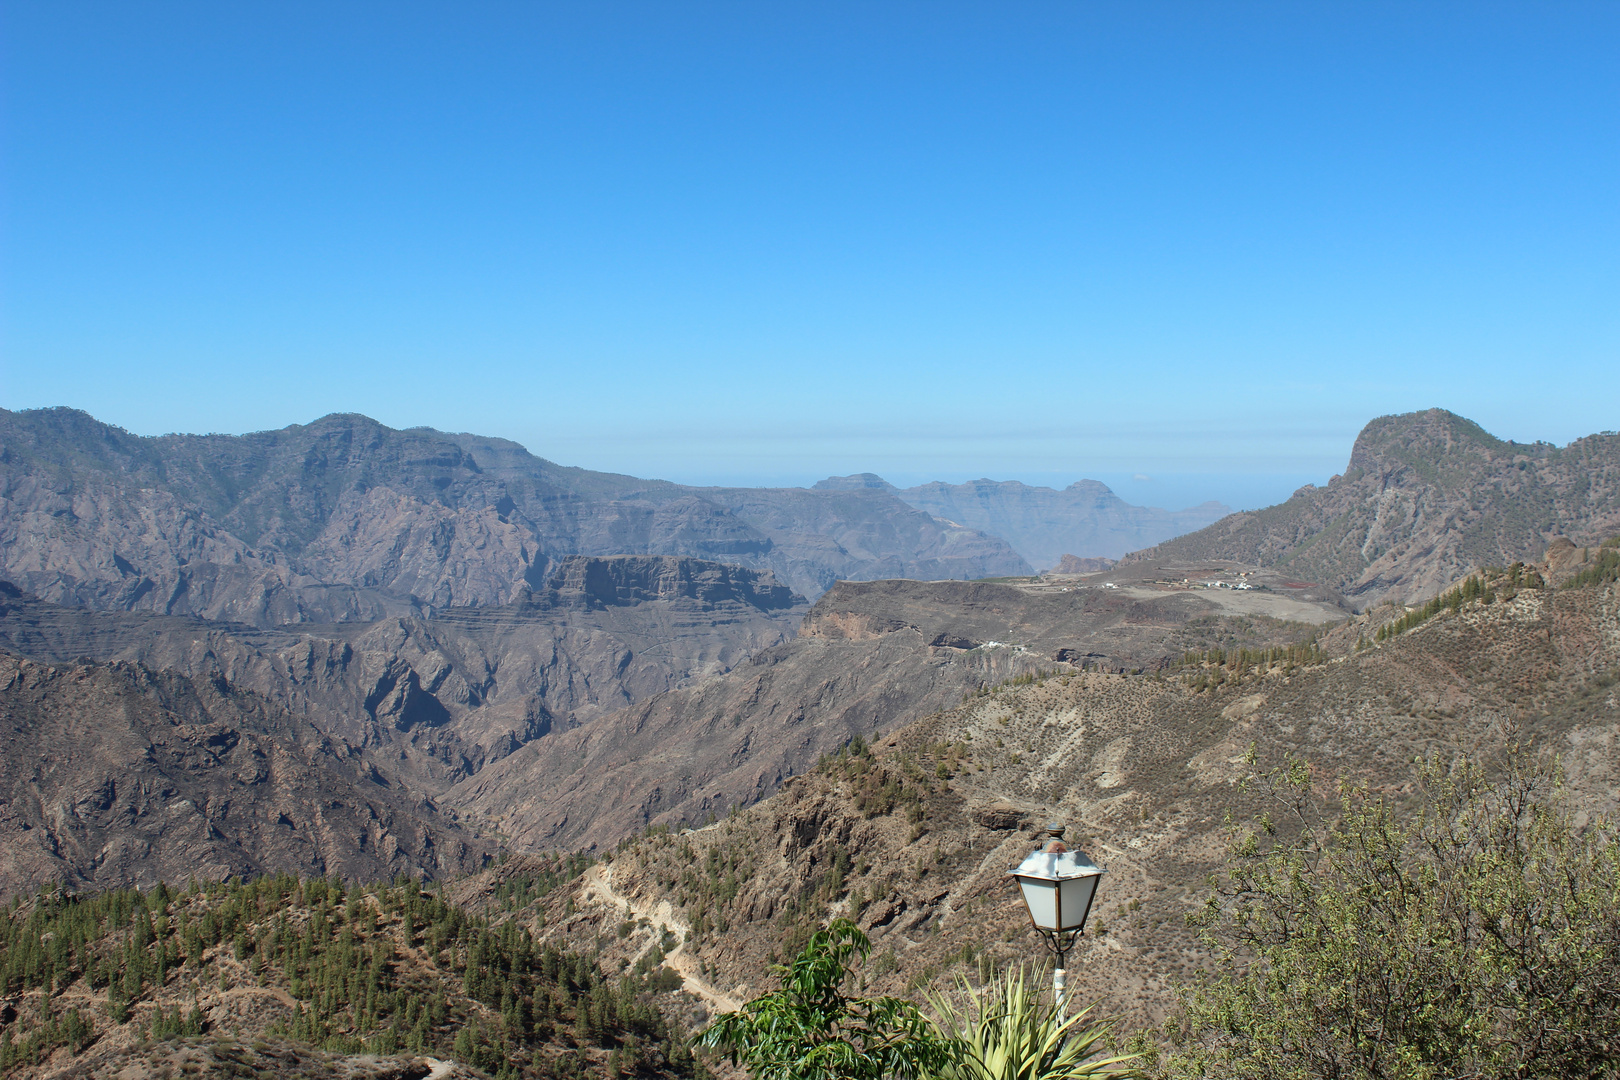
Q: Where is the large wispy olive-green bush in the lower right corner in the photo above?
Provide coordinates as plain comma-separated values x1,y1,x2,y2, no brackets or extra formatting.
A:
1166,751,1620,1080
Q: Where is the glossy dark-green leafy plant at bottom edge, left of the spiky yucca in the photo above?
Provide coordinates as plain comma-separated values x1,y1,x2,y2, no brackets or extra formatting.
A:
697,918,956,1080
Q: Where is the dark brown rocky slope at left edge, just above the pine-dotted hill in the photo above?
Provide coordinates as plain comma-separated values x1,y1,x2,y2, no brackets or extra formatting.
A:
0,654,492,894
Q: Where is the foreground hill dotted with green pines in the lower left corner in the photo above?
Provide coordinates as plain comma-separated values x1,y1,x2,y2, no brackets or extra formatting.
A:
0,860,698,1080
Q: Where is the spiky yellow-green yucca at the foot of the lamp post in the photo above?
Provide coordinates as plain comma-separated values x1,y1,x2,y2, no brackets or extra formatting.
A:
928,965,1136,1080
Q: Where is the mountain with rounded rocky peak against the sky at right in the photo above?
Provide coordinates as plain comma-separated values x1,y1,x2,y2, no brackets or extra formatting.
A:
1129,410,1620,607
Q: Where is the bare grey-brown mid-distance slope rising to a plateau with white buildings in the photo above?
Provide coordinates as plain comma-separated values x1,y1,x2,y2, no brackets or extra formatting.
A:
446,581,1341,850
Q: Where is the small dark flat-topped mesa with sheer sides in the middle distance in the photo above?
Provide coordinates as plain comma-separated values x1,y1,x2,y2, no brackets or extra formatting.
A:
535,555,805,612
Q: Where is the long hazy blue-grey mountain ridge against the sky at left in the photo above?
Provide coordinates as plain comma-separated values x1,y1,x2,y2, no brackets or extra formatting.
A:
0,408,1029,627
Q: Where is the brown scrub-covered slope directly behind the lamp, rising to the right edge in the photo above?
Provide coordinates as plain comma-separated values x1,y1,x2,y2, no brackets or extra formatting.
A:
570,559,1620,1023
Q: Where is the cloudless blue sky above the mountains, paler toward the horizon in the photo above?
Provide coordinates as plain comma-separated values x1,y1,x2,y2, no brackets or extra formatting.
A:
0,0,1620,505
